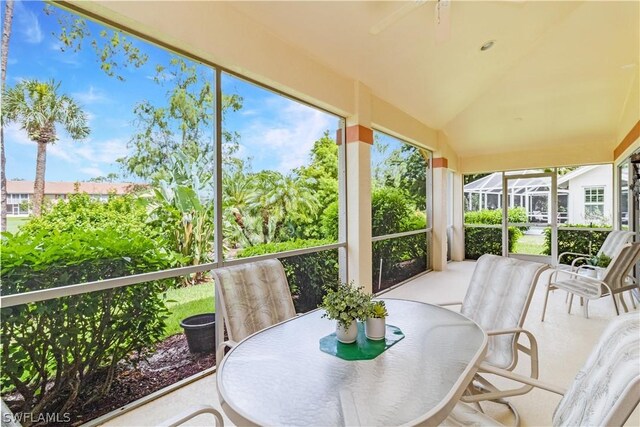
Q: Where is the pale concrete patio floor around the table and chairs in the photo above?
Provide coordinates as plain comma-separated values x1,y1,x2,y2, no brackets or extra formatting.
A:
104,261,640,426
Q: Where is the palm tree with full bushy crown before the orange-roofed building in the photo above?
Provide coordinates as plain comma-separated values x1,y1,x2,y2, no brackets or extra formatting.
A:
2,80,89,216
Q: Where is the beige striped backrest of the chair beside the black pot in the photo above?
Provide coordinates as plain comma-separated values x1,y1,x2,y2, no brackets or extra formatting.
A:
212,259,296,341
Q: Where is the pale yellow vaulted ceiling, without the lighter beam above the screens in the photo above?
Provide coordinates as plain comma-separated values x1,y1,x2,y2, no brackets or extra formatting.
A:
231,0,640,160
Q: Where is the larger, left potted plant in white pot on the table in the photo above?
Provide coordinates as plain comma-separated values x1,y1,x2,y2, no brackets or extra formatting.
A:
320,283,371,344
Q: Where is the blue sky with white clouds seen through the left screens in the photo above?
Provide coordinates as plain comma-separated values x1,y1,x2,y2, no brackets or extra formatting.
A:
2,1,338,181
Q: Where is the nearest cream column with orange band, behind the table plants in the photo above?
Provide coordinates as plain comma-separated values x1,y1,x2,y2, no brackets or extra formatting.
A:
346,82,373,293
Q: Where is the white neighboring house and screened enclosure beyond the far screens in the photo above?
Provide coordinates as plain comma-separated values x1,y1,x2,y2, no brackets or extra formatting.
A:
464,165,613,224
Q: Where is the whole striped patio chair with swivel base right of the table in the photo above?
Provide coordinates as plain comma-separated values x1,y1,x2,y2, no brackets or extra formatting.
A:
442,255,549,419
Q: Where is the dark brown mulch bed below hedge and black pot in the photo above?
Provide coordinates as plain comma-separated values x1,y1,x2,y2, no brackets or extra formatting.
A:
4,334,216,426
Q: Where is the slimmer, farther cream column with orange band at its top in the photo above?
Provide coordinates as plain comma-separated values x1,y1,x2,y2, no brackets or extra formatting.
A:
431,157,449,271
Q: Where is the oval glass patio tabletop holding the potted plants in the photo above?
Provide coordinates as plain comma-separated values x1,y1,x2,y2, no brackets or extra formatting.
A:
217,299,487,426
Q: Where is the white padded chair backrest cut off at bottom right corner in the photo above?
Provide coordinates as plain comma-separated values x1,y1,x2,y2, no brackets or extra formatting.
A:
553,312,640,426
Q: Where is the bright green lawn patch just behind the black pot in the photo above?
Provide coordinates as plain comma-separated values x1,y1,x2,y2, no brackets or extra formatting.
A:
164,282,216,338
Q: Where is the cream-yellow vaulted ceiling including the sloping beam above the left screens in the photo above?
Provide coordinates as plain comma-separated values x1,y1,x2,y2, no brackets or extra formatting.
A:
69,0,640,172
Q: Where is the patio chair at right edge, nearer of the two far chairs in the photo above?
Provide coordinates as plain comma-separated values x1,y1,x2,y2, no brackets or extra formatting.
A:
541,243,640,322
